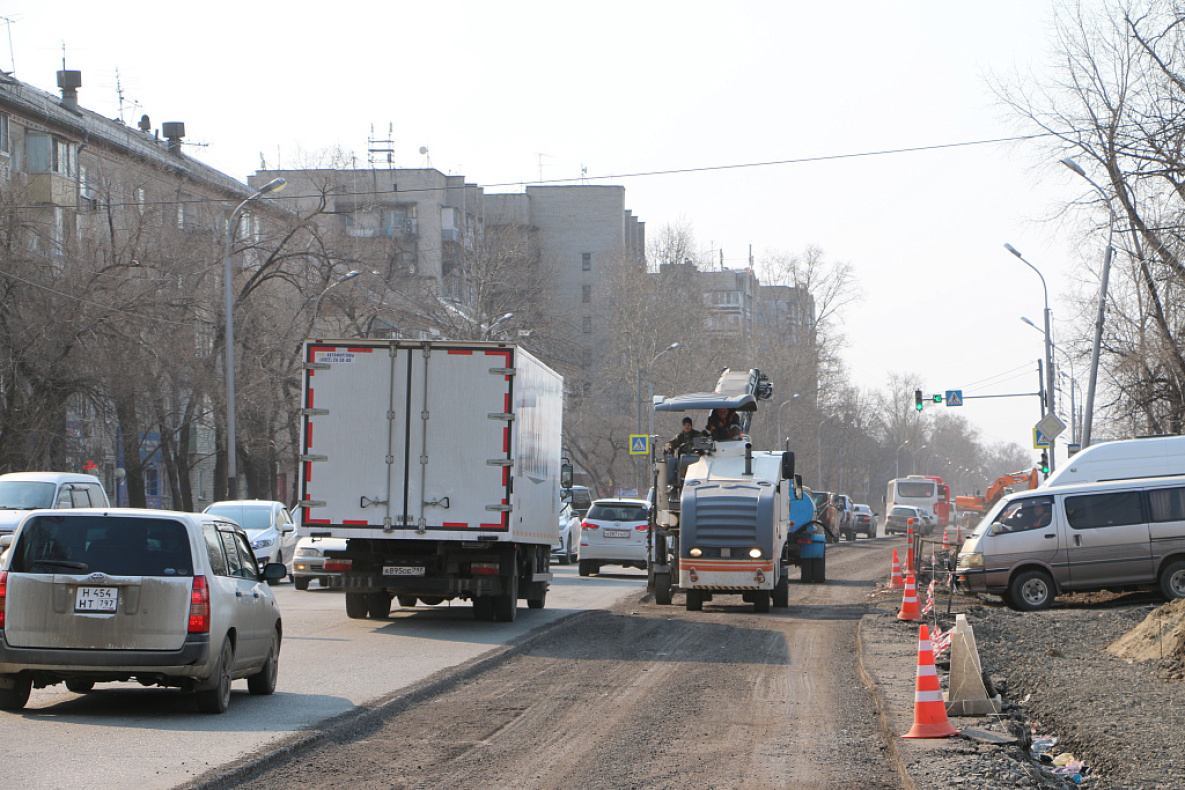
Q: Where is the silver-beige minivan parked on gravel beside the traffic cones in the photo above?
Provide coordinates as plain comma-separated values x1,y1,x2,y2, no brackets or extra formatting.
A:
955,476,1185,610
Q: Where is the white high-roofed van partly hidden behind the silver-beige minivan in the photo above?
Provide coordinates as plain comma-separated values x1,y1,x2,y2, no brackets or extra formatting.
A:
1042,436,1185,488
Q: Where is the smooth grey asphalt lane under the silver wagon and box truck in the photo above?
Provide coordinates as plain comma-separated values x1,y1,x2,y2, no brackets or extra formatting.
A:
0,566,645,790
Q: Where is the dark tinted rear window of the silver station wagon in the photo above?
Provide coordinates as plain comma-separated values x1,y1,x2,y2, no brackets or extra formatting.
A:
11,515,193,576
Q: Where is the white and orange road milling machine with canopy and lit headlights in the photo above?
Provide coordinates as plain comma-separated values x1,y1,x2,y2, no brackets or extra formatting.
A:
648,370,826,612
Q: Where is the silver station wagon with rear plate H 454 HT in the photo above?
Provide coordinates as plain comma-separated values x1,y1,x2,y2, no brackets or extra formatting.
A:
0,508,287,713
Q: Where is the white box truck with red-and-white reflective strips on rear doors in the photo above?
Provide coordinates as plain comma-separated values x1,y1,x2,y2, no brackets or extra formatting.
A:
297,340,571,622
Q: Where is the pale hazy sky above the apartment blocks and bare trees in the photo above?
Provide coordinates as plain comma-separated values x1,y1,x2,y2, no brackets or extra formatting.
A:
0,0,1101,469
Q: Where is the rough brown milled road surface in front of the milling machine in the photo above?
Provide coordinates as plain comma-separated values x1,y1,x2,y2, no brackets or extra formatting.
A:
215,540,899,790
